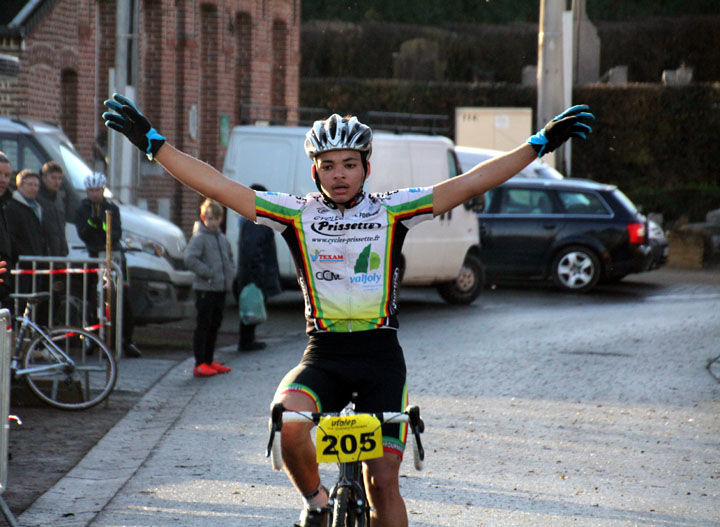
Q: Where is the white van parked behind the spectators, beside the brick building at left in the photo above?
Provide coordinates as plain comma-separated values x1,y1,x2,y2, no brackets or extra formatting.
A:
0,117,195,324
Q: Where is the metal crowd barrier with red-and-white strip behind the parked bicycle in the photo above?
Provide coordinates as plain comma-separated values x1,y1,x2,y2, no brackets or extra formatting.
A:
10,256,124,359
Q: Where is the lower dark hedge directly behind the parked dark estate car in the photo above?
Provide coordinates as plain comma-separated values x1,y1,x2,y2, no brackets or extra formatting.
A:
300,79,720,221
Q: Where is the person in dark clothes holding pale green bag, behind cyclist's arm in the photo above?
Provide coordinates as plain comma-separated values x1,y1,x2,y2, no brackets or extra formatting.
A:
235,184,282,351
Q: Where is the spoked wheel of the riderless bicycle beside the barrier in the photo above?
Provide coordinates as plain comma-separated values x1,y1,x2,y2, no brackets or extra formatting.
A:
24,327,117,410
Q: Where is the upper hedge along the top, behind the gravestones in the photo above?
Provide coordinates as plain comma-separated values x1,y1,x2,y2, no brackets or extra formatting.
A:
301,17,720,83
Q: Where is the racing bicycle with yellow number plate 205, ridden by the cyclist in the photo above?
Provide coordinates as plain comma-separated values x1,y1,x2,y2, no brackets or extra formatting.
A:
266,394,425,527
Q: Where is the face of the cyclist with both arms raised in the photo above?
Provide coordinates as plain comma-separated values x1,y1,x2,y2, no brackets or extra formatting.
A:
315,150,370,203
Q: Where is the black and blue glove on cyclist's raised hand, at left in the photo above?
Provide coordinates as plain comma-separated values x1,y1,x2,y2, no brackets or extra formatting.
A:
102,93,165,161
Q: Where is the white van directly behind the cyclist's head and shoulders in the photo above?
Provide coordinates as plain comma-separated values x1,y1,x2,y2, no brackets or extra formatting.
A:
223,126,484,304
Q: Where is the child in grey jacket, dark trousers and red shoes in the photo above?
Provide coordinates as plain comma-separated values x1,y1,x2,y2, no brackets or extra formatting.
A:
185,199,235,377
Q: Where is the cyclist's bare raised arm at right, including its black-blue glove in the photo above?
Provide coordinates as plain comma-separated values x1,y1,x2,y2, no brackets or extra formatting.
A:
433,105,595,216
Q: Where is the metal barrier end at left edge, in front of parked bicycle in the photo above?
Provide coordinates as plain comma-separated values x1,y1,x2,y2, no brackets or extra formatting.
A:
0,309,17,527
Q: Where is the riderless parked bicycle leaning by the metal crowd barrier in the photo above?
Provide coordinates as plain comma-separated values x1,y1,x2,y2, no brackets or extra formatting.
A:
10,293,118,410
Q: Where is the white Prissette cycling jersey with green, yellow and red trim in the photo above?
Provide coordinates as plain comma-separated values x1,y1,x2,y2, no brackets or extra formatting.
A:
255,187,433,333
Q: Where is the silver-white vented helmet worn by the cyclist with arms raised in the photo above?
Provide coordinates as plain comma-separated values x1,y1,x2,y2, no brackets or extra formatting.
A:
305,113,372,159
